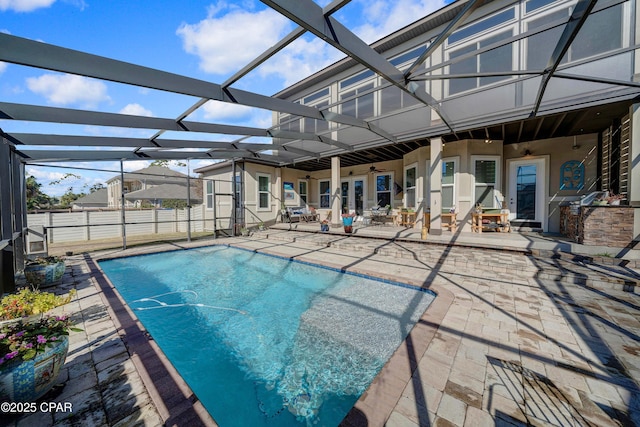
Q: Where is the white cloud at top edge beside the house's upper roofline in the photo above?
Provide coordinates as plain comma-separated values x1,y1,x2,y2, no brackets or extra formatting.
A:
353,0,447,43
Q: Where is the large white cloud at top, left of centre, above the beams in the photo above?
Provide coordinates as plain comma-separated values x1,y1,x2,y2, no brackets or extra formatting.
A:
176,2,292,74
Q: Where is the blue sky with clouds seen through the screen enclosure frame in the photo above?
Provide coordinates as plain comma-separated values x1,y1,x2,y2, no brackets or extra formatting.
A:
0,0,449,196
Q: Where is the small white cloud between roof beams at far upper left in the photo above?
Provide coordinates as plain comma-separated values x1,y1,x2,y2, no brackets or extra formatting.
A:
27,74,110,108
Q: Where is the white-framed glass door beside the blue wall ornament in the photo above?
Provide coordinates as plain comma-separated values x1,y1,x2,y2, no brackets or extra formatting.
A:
508,158,547,230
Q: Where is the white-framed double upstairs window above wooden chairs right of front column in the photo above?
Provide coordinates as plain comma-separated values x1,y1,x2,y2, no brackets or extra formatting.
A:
449,30,513,95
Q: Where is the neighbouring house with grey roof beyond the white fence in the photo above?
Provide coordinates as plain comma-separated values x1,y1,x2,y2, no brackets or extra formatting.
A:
107,166,192,209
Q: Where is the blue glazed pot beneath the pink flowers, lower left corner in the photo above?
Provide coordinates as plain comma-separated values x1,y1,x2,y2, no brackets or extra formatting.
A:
0,336,69,402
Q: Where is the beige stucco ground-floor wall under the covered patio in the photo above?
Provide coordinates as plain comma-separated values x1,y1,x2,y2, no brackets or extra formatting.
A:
199,134,598,232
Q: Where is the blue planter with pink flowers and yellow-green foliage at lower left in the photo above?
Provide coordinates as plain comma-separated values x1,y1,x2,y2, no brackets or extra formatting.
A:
0,289,77,402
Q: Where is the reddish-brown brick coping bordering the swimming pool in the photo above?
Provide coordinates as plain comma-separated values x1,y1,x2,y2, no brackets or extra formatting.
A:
85,242,454,427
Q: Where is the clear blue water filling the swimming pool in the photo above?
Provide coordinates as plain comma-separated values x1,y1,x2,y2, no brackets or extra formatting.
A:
100,246,434,427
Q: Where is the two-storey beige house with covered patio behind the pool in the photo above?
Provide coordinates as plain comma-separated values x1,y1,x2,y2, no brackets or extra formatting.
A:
195,0,640,237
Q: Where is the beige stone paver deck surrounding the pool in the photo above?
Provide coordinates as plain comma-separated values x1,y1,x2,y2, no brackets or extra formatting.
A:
2,230,640,427
